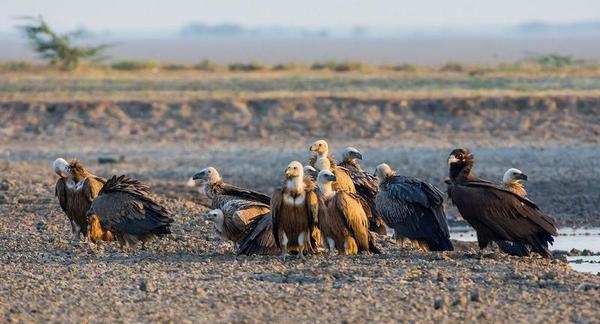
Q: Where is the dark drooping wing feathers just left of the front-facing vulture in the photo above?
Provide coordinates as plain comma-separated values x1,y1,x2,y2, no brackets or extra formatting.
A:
237,213,281,255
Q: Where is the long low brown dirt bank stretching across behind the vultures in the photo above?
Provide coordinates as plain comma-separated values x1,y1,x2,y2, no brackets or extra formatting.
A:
0,96,600,143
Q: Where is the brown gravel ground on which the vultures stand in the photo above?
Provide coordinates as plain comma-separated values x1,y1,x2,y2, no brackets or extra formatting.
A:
0,143,600,322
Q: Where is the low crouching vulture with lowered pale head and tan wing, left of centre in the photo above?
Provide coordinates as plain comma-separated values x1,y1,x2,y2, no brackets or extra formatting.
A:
208,199,270,245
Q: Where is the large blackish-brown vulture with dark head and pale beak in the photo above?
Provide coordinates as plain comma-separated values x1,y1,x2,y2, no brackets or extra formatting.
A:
448,148,558,258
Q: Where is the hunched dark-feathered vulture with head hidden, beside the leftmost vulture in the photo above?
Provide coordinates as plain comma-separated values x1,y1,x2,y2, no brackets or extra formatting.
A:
90,176,173,236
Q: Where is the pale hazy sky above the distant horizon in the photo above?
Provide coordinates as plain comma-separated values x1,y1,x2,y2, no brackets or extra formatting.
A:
0,0,600,31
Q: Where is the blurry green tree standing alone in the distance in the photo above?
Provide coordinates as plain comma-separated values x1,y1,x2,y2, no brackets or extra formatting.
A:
19,16,110,70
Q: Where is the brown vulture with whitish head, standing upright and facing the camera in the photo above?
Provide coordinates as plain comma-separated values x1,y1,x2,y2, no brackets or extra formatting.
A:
271,161,319,260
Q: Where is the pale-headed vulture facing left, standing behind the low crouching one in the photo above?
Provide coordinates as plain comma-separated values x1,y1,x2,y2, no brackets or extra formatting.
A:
192,167,271,209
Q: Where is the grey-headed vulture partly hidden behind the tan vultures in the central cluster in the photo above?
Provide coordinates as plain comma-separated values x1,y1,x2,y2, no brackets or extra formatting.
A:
338,147,387,235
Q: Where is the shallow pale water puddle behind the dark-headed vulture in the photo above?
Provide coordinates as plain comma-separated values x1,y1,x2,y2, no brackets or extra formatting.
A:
450,227,600,273
